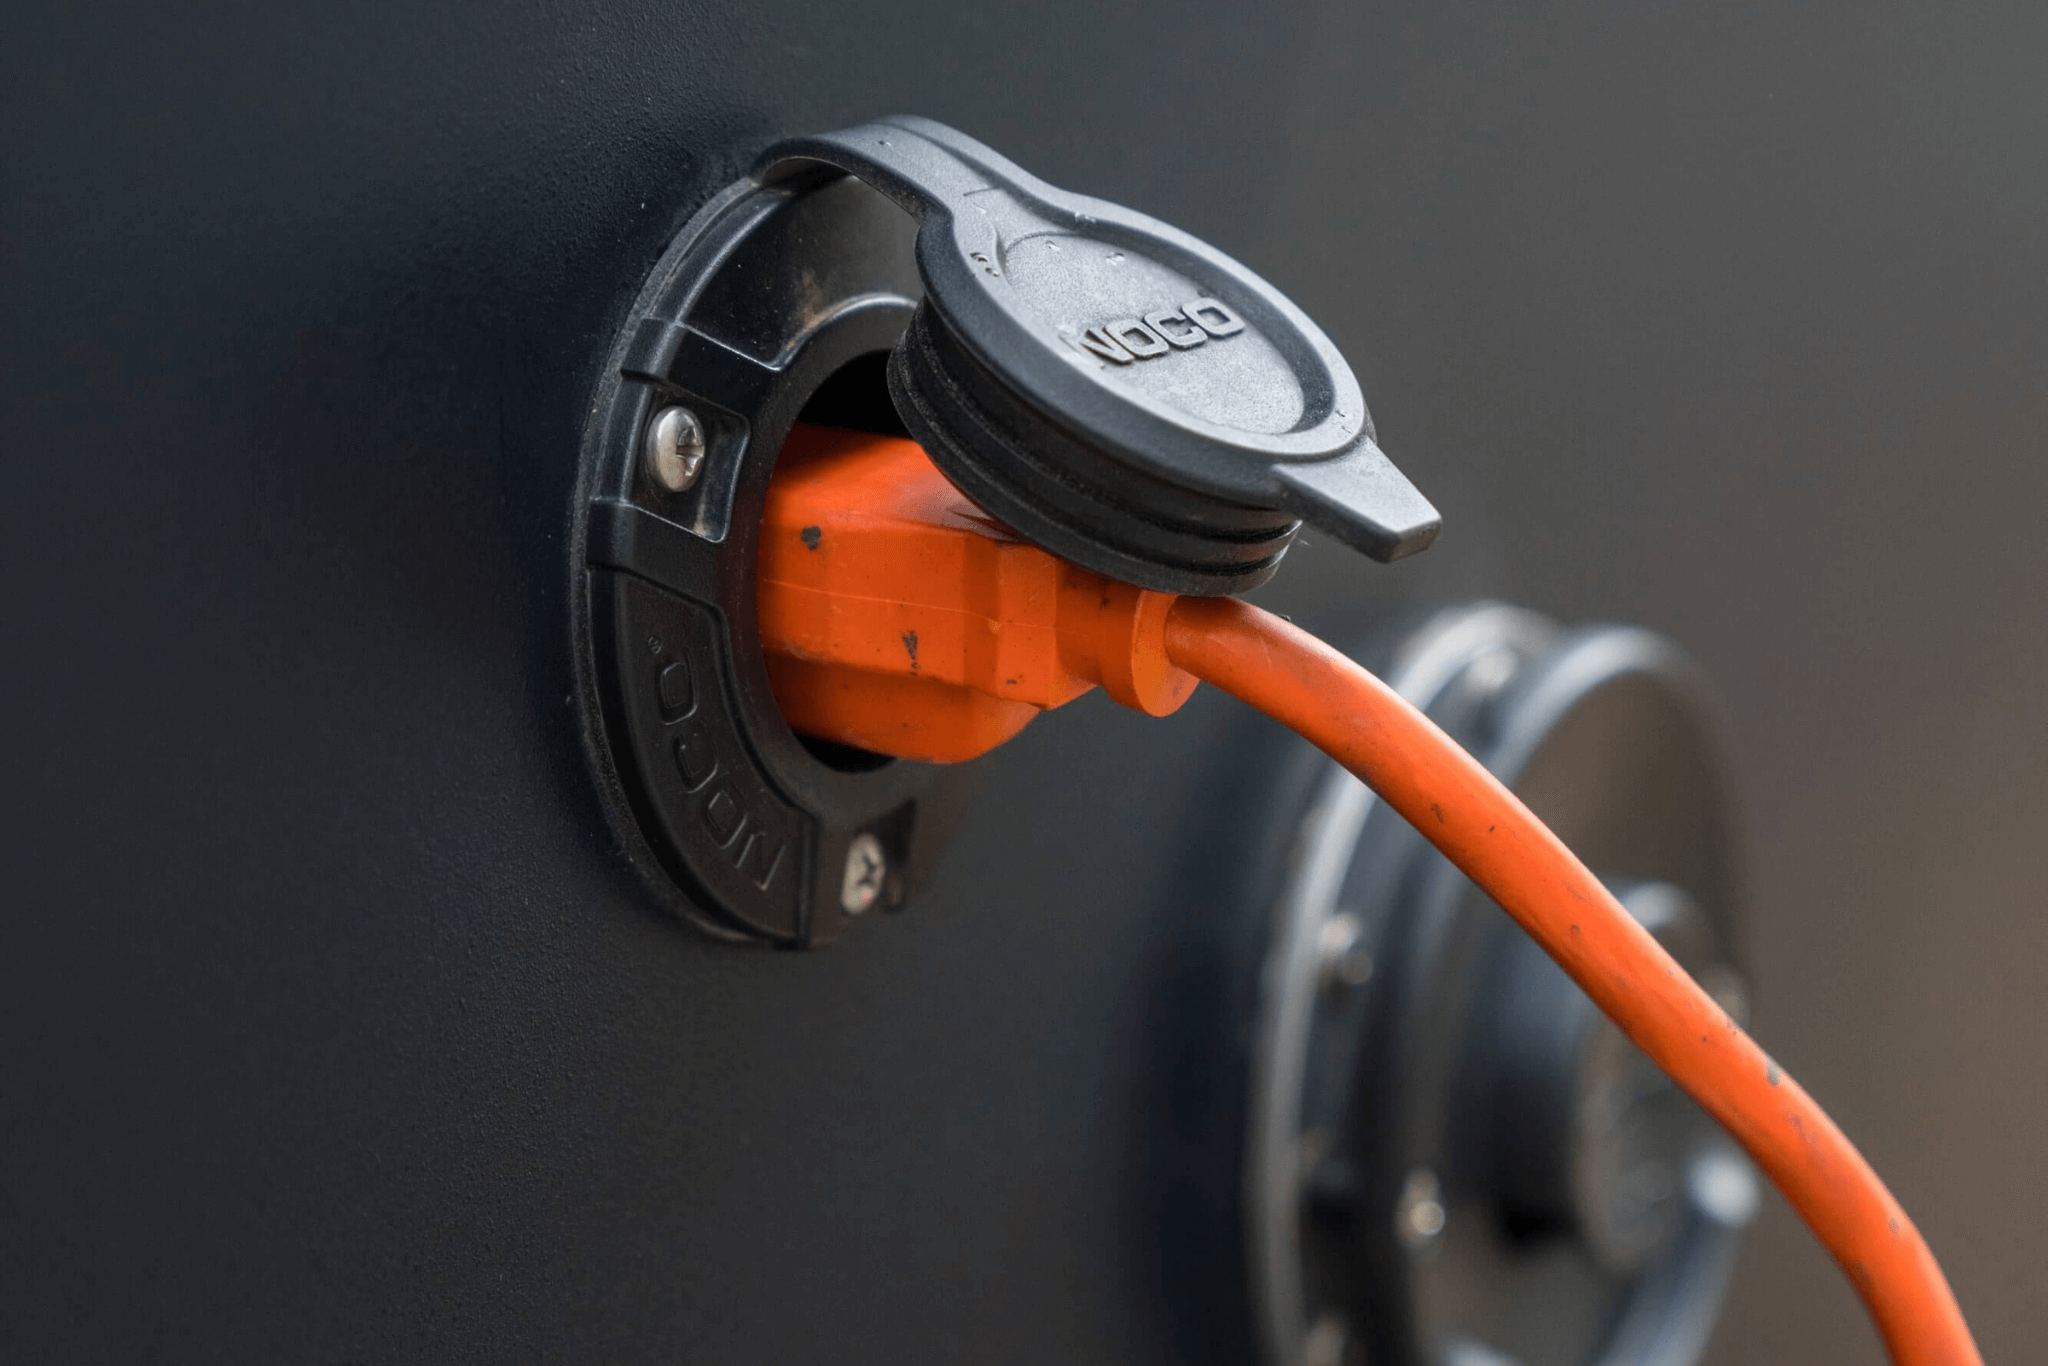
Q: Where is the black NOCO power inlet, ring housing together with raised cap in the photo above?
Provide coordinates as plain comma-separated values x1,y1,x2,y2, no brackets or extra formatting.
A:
571,117,1438,944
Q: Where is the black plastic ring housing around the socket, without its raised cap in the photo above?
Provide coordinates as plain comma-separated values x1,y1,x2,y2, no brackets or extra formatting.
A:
573,172,965,946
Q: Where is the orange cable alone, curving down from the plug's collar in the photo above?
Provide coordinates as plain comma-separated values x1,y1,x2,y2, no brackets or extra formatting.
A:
1165,598,1982,1366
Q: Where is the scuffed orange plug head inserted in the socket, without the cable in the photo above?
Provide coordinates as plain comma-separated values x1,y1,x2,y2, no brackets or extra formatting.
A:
754,424,1194,764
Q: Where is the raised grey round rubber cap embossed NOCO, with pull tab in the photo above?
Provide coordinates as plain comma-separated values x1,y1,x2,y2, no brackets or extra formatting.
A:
764,117,1438,594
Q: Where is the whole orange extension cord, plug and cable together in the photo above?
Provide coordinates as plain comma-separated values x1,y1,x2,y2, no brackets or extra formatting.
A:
756,426,1982,1366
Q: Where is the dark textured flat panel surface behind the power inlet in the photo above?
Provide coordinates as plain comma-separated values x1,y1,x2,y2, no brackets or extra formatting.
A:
0,2,2048,1362
